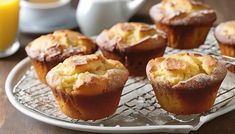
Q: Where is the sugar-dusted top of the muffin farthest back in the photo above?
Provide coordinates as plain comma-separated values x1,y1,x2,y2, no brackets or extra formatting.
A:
149,0,216,25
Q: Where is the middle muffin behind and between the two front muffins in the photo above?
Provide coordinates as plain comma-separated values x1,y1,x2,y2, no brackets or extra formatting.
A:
96,22,167,75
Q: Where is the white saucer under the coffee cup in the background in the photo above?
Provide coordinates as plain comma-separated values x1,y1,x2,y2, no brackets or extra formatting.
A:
20,9,78,34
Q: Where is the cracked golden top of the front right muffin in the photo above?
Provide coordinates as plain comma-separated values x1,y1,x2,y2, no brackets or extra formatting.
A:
147,53,227,87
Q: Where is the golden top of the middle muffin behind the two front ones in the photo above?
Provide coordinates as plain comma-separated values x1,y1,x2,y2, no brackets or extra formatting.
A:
96,22,166,52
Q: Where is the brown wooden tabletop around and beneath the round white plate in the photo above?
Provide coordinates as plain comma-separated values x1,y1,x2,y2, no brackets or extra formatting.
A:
0,0,235,134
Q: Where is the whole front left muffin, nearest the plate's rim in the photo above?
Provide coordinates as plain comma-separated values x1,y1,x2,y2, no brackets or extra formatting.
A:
46,54,128,120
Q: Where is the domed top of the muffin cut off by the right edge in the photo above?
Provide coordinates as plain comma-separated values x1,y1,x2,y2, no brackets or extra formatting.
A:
215,21,235,45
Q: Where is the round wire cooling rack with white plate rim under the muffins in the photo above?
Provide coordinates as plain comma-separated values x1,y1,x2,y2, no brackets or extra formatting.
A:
6,30,235,133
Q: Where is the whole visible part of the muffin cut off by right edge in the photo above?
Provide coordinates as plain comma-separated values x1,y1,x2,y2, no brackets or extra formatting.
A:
215,21,235,73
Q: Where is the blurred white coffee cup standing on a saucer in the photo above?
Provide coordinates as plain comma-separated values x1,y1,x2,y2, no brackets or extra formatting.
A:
20,0,71,28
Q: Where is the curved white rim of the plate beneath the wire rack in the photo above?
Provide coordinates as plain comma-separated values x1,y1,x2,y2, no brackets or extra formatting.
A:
5,58,235,133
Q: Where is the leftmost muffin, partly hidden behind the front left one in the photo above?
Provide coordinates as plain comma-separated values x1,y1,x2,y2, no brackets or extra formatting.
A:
25,30,97,83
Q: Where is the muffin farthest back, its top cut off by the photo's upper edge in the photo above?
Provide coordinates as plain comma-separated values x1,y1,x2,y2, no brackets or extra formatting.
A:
149,0,216,49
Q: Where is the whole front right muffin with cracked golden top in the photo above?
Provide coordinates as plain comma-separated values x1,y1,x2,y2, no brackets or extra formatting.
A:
146,53,227,115
